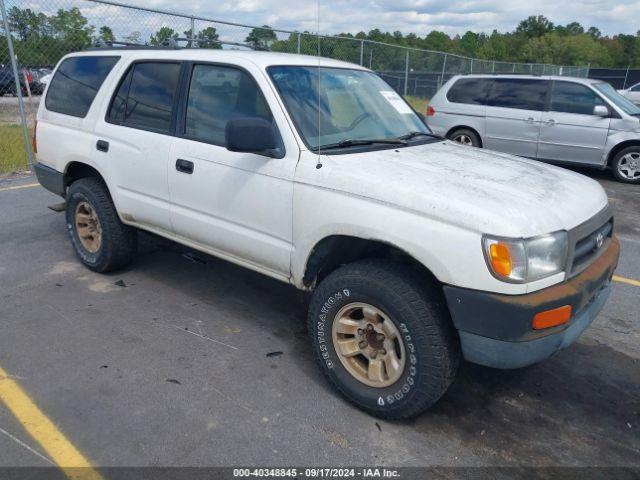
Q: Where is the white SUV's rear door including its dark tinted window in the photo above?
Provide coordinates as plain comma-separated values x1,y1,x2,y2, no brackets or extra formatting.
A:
94,60,182,231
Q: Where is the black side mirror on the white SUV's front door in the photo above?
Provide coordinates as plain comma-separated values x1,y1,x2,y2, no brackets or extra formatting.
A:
225,117,280,157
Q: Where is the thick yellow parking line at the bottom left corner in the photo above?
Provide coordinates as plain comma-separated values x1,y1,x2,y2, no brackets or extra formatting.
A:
0,367,102,480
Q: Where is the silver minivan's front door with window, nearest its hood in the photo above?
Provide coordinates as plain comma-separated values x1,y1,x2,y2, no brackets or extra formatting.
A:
538,81,611,165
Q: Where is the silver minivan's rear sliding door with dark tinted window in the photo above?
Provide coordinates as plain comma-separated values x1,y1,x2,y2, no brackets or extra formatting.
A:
483,78,549,158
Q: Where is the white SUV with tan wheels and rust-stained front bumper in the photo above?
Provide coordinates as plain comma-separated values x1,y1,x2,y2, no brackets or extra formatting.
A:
34,48,619,418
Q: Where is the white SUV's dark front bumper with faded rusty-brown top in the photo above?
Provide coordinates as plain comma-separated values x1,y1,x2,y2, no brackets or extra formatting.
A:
444,237,620,369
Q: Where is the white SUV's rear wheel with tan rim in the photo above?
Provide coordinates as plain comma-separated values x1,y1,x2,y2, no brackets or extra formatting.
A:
65,178,138,273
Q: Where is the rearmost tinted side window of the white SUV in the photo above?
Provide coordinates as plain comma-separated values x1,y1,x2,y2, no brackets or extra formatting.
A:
45,56,120,118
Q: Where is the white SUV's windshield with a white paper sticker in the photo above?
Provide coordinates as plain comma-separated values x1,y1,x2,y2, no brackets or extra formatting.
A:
269,66,430,150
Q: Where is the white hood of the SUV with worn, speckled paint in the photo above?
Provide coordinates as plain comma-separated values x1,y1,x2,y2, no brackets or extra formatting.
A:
312,141,608,237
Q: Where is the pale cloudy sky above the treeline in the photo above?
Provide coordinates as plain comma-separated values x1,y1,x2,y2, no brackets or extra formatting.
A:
123,0,640,36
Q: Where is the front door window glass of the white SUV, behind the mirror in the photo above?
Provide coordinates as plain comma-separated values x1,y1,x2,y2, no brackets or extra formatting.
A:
184,65,271,146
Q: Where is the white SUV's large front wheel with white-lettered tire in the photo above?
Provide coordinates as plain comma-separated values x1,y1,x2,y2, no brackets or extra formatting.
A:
308,259,460,420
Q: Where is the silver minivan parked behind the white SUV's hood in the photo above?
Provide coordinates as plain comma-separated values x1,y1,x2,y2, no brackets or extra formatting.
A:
426,75,640,183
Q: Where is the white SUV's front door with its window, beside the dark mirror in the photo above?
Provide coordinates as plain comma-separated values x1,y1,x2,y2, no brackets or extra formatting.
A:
168,64,299,277
